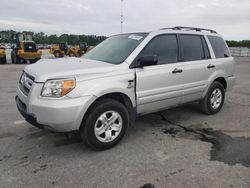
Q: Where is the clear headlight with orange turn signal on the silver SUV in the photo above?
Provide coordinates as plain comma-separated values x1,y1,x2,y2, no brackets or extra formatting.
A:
41,79,75,98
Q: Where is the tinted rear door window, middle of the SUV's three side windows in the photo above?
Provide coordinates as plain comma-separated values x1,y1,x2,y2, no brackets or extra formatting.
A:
180,35,205,61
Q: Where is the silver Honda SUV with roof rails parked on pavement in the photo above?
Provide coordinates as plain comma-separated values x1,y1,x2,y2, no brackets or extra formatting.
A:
16,27,235,149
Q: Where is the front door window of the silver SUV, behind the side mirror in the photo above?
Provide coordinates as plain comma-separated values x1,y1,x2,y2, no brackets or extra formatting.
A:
140,35,178,64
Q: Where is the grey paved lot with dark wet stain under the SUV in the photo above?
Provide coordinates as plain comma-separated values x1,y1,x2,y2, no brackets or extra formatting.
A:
0,58,250,188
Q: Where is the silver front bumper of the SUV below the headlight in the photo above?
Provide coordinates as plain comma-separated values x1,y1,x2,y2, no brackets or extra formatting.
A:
16,83,95,132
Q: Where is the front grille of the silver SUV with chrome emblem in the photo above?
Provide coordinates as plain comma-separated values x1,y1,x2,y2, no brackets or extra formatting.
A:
19,72,35,96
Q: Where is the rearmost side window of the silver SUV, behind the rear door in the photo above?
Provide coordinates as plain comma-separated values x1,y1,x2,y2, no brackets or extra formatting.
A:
207,36,230,58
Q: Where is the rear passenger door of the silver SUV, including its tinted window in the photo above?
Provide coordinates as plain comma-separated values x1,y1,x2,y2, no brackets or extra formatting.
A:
179,34,214,103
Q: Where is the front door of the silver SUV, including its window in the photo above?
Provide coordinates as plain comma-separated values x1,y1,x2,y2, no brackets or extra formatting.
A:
135,34,183,114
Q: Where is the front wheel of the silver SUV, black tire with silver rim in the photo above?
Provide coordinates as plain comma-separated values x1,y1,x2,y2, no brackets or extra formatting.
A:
80,99,130,150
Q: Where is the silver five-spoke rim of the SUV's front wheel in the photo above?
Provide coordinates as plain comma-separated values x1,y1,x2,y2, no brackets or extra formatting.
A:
95,111,123,143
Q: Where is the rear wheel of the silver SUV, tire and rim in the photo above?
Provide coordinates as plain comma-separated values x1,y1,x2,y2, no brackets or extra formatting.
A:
200,81,225,115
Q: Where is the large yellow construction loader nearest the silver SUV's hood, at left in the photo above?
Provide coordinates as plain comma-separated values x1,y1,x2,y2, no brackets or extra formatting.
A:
11,32,42,64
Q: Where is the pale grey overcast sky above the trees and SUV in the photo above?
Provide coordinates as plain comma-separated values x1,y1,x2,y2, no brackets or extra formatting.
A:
0,0,250,40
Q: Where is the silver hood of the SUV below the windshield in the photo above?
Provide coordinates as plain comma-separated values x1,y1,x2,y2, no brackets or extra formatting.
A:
24,57,117,82
